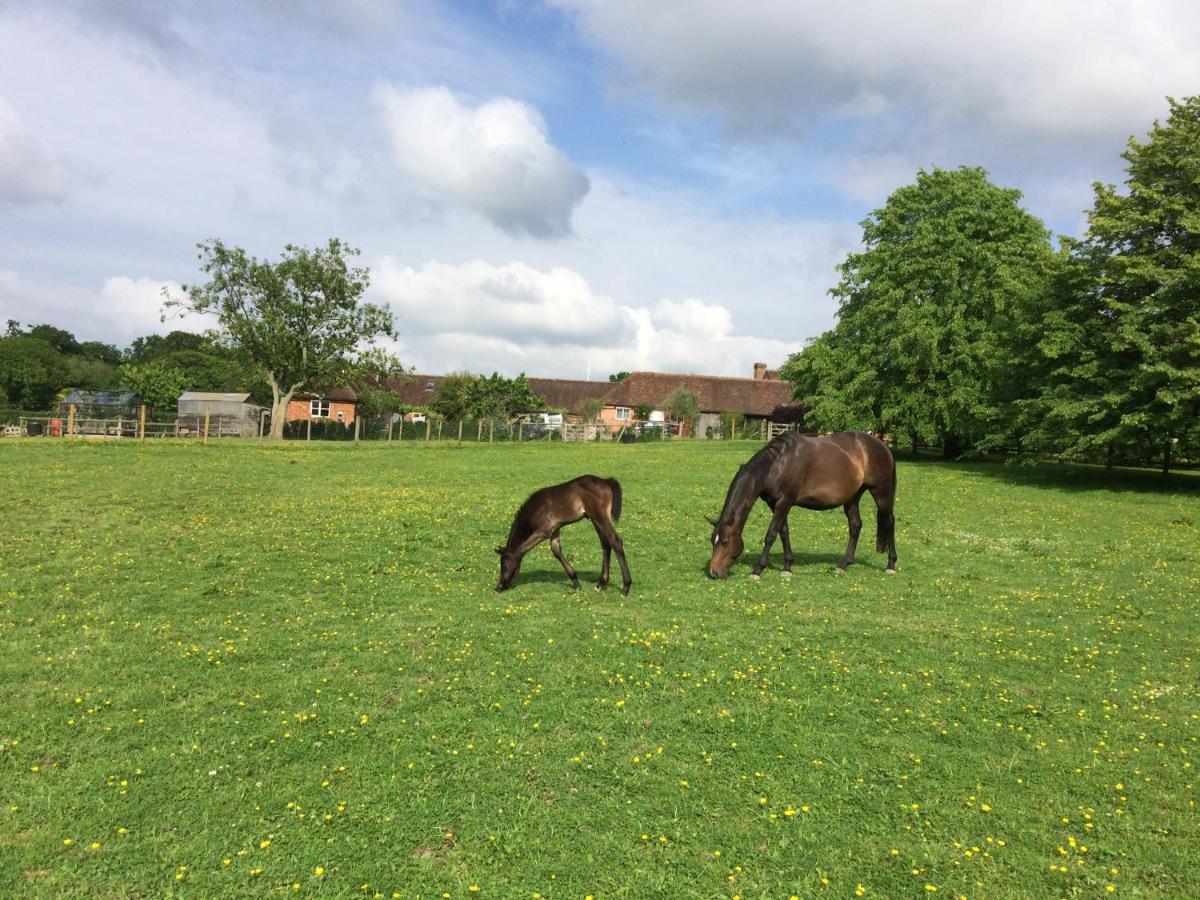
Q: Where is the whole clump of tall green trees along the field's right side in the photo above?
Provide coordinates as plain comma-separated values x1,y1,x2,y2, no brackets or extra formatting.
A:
782,97,1200,472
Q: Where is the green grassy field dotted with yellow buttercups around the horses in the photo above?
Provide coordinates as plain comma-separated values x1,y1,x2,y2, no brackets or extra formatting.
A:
0,440,1200,900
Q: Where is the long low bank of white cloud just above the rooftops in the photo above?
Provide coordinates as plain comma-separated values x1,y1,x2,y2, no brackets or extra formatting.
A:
373,260,800,378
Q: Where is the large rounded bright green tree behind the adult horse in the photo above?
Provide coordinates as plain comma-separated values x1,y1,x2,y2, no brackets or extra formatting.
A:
782,167,1054,455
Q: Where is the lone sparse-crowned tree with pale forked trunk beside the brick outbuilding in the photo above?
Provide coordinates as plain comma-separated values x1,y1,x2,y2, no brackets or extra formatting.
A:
163,238,394,439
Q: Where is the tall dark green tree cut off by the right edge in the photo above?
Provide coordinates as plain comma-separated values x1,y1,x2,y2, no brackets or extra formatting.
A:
1043,97,1200,474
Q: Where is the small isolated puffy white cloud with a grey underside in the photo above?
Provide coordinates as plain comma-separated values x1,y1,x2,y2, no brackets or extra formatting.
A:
374,85,589,236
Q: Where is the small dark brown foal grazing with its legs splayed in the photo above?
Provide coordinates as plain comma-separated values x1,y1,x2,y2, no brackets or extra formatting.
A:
496,475,634,595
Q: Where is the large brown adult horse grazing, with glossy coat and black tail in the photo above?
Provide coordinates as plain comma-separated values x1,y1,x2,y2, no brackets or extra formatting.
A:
708,431,896,578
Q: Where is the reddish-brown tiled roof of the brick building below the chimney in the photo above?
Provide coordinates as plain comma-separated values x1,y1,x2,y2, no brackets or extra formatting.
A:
606,372,792,415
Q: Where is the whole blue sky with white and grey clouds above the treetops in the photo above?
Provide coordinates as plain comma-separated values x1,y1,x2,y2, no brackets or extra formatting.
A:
0,0,1200,378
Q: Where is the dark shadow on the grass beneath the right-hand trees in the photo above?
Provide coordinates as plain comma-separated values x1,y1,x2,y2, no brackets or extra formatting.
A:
895,451,1200,494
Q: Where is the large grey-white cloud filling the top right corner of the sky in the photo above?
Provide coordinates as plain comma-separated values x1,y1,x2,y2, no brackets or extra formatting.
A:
552,0,1200,148
